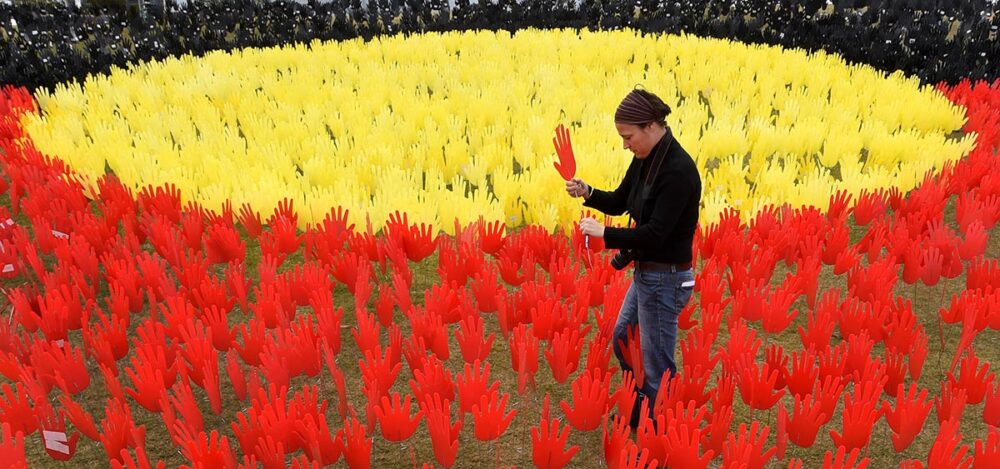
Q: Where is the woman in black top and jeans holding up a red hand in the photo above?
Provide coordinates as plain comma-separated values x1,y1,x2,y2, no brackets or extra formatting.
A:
566,89,701,428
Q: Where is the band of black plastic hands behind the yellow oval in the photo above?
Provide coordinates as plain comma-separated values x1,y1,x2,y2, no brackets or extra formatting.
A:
0,0,1000,90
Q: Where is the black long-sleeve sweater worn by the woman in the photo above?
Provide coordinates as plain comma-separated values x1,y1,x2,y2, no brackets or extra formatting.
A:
583,131,701,264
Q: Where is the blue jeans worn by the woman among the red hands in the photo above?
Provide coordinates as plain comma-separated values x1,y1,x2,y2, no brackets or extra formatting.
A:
614,269,694,410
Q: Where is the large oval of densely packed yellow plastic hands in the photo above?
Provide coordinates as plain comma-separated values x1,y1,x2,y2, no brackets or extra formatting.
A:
26,31,974,231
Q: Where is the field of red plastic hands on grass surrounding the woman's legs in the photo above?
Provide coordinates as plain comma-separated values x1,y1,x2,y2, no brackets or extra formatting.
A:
0,76,1000,468
